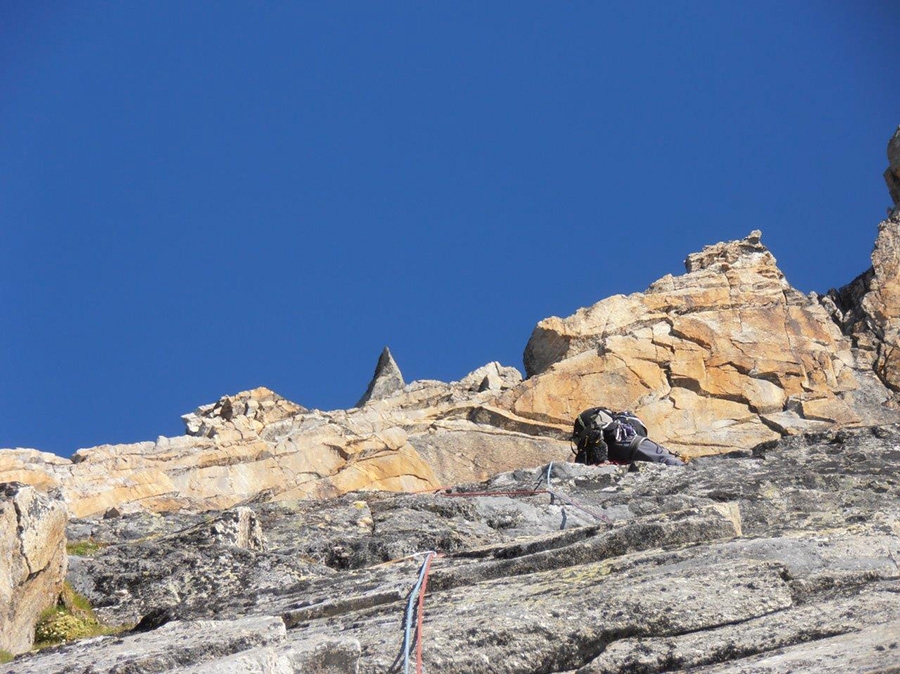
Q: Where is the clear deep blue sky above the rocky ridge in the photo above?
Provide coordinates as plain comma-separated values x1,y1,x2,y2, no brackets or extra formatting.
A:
0,0,900,456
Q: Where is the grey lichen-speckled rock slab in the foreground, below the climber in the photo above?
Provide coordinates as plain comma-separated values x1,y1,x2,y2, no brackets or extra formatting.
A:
3,426,900,674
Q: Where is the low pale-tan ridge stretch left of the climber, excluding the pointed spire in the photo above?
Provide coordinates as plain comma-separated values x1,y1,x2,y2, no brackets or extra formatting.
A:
0,363,569,516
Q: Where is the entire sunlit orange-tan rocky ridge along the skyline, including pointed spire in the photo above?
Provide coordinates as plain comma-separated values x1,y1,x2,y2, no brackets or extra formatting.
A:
8,210,900,516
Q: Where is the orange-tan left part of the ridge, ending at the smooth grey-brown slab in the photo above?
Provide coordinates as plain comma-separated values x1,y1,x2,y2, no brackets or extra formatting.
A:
0,389,438,516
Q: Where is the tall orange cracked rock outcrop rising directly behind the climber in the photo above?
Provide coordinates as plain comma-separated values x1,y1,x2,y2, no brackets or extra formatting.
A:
510,232,898,457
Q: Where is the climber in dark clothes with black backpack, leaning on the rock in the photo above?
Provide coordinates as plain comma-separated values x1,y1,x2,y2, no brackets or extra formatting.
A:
572,407,684,466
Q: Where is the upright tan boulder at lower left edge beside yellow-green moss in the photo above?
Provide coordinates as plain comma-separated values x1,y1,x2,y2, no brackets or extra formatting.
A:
0,482,68,654
